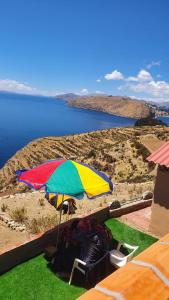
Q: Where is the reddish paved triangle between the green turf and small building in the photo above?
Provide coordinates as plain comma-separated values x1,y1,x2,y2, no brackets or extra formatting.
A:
120,207,154,233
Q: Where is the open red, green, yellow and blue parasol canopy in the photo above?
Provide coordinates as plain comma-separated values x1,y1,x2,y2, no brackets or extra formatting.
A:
17,159,113,199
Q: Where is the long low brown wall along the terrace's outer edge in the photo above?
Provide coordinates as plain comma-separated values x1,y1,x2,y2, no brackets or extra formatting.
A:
0,200,152,274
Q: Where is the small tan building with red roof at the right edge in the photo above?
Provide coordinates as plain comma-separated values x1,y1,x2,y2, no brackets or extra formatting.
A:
147,141,169,236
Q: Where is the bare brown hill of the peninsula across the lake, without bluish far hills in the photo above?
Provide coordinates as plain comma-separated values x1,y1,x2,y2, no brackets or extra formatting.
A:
69,96,151,119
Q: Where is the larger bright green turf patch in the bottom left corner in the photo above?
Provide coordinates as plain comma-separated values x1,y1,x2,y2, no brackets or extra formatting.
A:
0,255,85,300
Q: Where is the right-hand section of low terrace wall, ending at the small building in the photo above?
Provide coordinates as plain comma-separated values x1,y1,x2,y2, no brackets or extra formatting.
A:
110,199,152,218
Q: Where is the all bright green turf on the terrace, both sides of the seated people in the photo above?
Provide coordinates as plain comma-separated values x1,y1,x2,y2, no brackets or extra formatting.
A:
0,219,156,300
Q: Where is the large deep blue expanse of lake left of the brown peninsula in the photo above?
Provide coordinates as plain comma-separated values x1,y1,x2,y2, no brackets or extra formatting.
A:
0,93,145,167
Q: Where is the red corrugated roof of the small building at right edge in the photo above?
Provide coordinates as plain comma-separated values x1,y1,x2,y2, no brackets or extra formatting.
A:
147,141,169,167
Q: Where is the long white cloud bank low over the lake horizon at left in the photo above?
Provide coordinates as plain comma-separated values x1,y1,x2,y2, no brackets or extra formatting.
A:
0,79,56,96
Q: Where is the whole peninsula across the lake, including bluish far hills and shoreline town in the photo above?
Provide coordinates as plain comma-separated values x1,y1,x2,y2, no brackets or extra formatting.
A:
57,93,168,119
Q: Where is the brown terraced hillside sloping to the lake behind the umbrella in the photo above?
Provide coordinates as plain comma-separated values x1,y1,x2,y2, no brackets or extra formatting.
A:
0,126,169,193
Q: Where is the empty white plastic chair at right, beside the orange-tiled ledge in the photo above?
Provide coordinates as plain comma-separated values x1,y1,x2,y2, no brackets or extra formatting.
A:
109,242,138,268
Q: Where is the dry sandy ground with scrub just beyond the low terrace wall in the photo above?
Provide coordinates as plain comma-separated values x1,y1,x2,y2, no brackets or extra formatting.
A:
0,182,153,251
